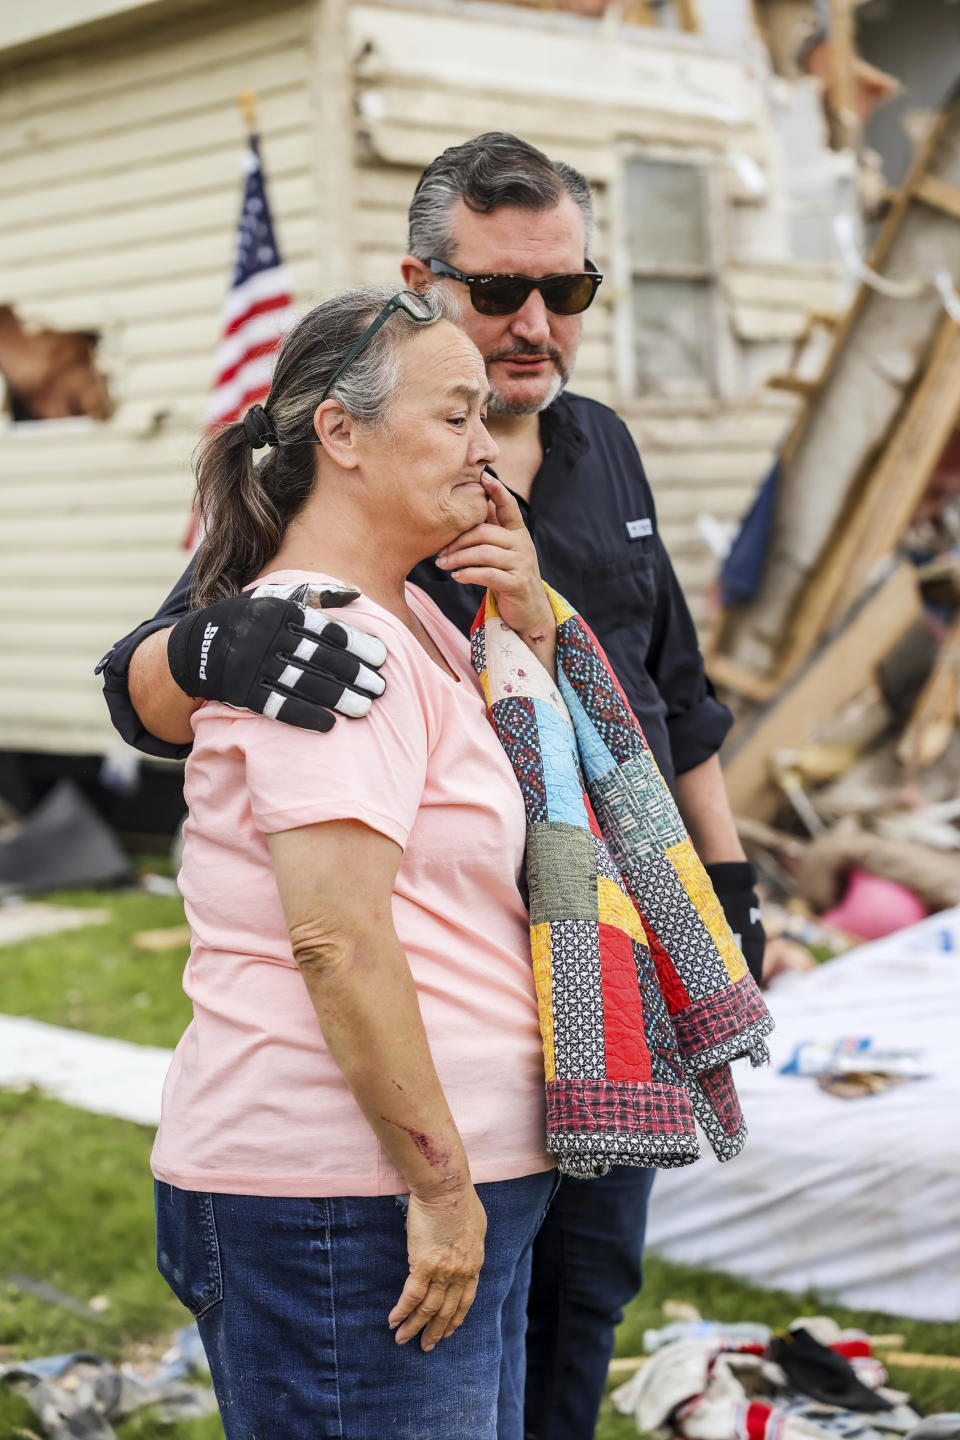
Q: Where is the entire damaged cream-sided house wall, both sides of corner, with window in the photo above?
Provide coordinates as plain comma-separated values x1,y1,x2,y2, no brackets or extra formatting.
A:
0,0,841,752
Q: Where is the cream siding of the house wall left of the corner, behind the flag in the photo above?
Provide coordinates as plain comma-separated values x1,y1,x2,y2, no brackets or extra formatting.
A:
0,4,318,752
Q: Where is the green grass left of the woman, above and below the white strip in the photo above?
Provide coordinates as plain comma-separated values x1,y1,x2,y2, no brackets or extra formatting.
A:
0,867,210,1440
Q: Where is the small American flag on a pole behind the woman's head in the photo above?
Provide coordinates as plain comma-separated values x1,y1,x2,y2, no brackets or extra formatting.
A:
207,135,296,426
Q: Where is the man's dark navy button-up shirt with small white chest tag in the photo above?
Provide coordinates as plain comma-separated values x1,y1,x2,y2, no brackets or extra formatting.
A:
104,395,731,783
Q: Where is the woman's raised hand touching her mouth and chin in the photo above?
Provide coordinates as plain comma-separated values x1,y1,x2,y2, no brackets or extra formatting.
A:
436,472,557,647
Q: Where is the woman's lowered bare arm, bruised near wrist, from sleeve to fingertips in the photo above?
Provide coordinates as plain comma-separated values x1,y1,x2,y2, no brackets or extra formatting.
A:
266,821,486,1351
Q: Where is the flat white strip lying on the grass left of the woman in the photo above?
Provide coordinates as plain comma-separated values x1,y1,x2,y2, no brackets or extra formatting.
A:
0,1015,173,1126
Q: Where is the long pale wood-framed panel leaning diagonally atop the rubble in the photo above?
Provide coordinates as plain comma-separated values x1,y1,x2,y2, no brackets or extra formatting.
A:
707,87,960,693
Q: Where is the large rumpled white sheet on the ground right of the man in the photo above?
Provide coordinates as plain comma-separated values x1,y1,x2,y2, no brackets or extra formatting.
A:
648,907,960,1320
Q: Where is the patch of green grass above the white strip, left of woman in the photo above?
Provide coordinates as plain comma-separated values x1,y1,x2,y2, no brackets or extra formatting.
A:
0,890,190,1045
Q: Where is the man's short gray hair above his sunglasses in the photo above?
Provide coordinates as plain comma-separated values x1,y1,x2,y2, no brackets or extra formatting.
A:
410,130,593,261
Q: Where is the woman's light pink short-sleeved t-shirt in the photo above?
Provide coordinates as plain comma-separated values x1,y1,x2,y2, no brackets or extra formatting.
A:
151,570,551,1195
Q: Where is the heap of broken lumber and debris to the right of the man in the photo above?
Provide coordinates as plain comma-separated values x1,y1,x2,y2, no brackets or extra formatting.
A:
707,84,960,965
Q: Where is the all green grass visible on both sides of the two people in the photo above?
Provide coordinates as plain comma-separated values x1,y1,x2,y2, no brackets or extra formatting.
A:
0,891,960,1440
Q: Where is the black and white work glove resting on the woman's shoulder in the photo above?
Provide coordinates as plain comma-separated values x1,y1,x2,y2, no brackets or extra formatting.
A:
167,585,387,732
